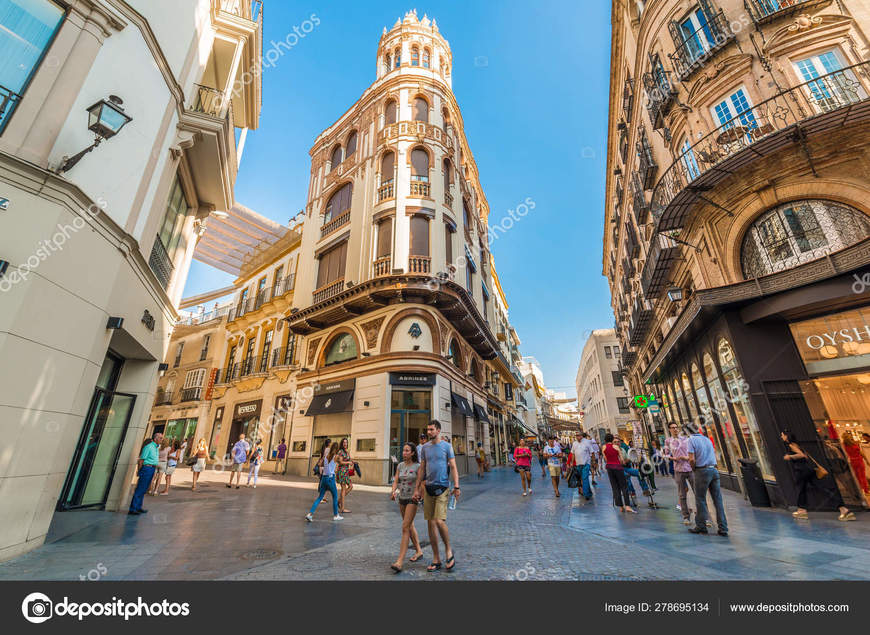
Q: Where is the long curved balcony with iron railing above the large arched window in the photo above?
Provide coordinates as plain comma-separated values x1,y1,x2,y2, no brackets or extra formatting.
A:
650,62,870,236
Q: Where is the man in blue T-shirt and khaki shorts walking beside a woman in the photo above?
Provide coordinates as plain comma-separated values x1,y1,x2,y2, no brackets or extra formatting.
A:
414,421,460,573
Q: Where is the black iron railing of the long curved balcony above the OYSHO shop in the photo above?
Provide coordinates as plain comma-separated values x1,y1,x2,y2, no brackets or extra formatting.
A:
650,62,870,229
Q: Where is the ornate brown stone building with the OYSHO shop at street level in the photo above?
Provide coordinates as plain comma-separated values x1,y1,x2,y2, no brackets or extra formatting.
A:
603,0,870,508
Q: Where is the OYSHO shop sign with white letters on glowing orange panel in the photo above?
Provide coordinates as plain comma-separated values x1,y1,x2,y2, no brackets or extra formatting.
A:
789,308,870,372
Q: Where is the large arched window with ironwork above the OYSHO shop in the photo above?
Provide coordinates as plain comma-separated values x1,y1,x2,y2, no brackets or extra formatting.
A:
740,199,870,278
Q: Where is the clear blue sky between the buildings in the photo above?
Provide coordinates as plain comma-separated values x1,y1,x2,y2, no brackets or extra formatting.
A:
185,0,613,395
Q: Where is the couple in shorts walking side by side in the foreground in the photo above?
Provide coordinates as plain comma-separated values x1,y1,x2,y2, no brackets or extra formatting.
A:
390,421,460,573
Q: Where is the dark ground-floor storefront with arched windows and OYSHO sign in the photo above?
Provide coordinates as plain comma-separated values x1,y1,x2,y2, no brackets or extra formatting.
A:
645,276,870,509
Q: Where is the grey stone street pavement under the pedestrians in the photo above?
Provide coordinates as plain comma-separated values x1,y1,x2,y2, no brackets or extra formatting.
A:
0,468,870,580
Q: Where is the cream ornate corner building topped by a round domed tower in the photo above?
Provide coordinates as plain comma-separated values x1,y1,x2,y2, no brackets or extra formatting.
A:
286,12,519,483
